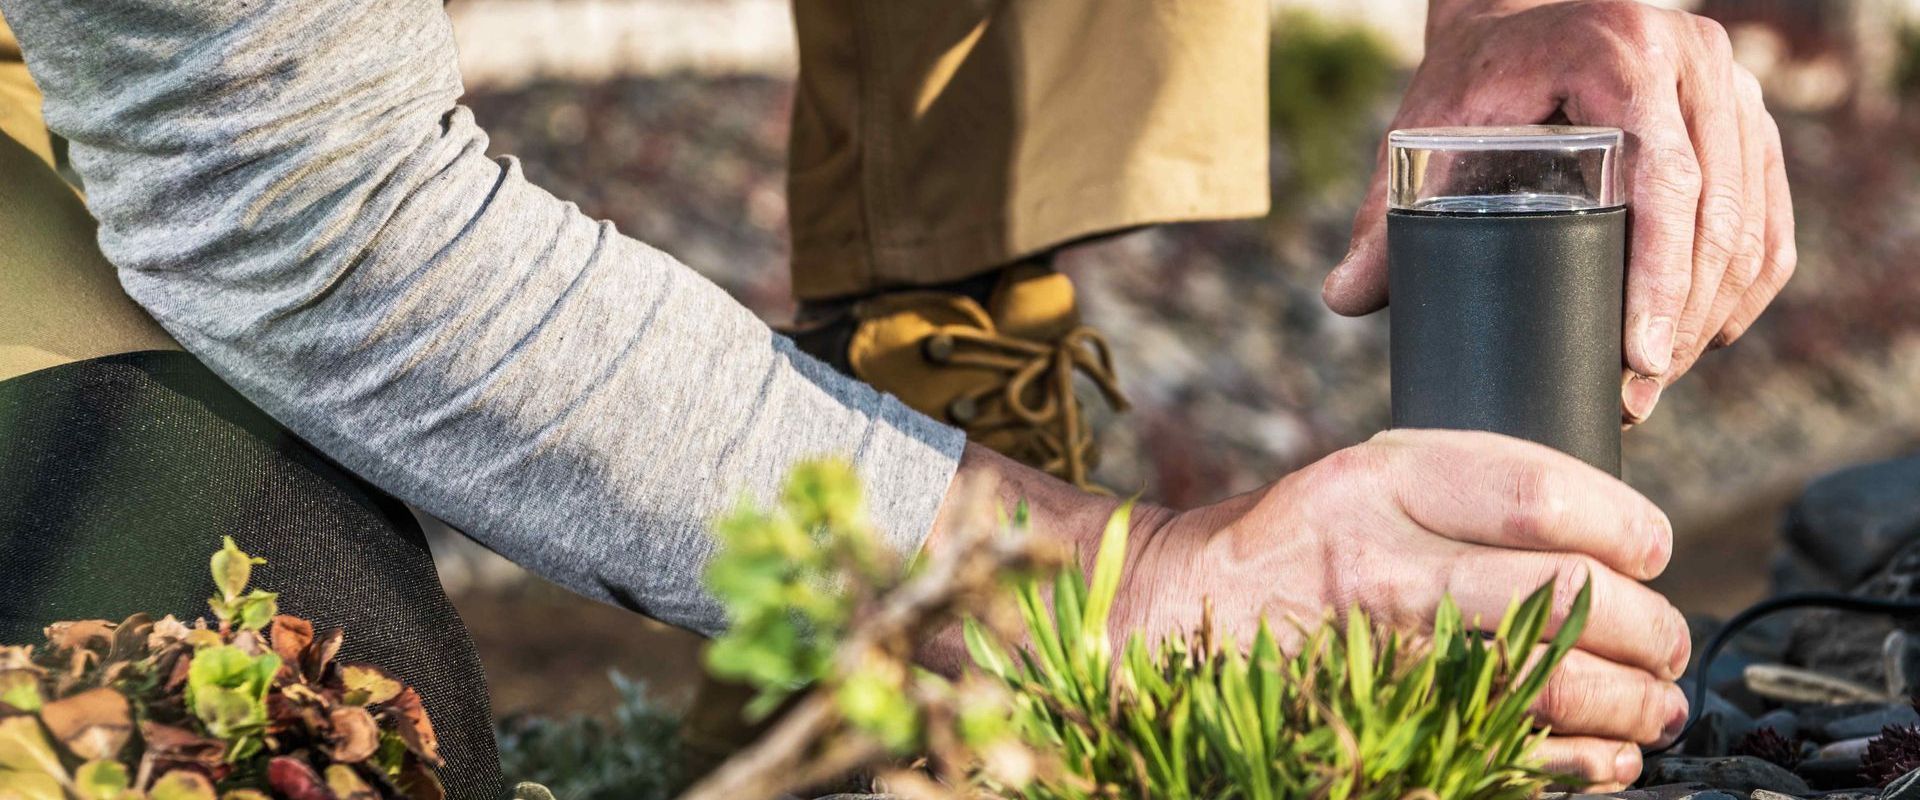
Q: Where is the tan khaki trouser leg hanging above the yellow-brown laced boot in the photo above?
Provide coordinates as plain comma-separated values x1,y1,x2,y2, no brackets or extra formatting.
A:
787,0,1267,299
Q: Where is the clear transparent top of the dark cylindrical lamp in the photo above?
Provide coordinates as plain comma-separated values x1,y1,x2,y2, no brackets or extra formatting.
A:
1386,125,1626,215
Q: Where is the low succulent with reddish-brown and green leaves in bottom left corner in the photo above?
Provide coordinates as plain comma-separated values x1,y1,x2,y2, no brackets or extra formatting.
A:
0,537,442,800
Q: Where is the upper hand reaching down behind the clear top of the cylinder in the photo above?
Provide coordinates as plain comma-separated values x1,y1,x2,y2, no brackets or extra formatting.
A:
1325,0,1795,422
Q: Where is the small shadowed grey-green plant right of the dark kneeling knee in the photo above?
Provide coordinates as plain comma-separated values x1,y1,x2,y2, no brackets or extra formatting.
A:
497,671,685,800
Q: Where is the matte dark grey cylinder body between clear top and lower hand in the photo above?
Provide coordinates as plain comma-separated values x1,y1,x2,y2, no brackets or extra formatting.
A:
1386,209,1626,476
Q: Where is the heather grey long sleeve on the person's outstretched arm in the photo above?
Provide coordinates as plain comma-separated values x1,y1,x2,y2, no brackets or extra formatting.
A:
0,0,962,633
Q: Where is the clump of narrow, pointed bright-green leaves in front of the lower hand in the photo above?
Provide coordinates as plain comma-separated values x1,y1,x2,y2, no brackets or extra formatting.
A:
966,508,1590,800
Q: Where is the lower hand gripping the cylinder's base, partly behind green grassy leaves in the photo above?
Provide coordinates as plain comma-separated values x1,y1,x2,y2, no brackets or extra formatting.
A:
1116,430,1690,785
